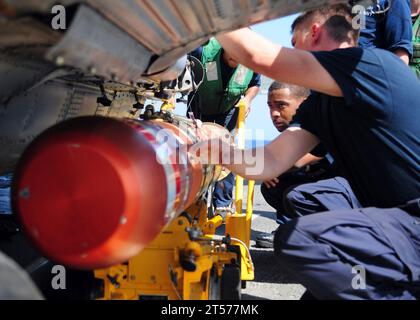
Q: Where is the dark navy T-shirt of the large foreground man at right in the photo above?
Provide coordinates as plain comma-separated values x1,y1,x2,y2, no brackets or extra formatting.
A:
292,48,420,208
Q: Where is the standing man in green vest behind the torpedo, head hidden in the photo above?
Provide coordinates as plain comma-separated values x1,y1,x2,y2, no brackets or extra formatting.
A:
188,38,261,215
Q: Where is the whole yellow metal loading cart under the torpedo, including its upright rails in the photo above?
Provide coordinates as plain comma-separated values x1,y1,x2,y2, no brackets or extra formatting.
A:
95,101,254,300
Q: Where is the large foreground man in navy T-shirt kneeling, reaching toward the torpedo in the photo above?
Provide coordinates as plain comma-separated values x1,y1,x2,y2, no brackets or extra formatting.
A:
198,5,420,299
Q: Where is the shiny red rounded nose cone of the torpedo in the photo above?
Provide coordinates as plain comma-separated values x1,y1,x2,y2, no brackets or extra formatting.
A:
13,117,168,268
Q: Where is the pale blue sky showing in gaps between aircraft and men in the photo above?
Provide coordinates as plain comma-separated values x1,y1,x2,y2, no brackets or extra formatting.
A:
171,15,297,140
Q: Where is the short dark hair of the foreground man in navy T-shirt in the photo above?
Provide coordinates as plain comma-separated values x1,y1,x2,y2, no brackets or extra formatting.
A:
292,3,360,45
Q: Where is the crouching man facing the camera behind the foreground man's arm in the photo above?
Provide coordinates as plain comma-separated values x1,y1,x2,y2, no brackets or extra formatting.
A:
255,81,358,248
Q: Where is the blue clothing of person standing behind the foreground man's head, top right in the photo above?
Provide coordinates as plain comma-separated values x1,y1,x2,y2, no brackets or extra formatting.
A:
359,0,413,57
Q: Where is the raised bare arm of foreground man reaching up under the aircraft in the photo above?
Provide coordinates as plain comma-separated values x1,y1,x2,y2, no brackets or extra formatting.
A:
217,28,343,97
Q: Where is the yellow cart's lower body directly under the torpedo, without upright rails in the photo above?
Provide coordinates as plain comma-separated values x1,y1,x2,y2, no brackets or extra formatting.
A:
95,201,237,300
